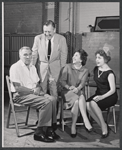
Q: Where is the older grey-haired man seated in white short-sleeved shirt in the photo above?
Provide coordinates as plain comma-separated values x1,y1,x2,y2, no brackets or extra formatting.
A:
10,46,60,142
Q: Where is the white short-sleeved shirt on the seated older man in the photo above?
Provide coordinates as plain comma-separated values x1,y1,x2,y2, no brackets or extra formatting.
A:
10,60,39,92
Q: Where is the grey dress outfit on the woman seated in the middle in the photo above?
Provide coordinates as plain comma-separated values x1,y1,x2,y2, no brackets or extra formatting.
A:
60,63,89,109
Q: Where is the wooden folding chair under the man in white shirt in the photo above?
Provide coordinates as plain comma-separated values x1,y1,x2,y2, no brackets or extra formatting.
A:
6,76,30,137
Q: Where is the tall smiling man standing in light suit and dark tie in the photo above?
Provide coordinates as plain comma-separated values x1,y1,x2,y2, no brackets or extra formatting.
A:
32,20,67,113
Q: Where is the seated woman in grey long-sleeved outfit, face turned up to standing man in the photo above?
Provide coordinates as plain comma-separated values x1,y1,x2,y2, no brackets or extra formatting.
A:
60,49,92,138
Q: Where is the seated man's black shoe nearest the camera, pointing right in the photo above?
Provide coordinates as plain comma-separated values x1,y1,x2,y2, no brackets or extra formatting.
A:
34,133,54,142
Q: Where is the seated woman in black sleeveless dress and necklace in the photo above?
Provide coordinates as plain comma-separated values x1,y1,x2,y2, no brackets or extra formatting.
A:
87,47,117,138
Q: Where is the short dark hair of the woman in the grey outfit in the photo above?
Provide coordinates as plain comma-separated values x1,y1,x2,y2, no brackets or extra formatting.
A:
76,49,88,66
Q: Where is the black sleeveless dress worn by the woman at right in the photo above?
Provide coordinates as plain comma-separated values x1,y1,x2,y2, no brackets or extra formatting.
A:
87,66,118,110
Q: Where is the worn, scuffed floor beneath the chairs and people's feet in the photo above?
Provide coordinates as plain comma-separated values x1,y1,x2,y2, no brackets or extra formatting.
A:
2,94,120,148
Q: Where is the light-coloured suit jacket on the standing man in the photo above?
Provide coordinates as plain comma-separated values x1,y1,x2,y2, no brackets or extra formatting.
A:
32,33,68,82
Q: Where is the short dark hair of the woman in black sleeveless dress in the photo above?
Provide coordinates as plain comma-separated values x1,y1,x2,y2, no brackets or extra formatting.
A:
95,49,111,63
